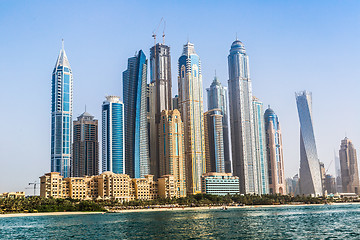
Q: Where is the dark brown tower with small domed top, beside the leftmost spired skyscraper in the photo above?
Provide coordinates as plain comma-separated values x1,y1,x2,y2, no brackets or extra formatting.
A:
72,112,99,177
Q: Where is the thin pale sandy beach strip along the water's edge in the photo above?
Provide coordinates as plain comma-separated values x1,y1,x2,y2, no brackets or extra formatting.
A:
0,202,360,218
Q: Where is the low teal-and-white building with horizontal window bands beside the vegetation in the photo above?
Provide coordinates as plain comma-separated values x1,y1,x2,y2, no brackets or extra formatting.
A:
202,172,240,195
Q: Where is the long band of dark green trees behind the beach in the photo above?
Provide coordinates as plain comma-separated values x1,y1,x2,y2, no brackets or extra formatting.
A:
0,194,332,213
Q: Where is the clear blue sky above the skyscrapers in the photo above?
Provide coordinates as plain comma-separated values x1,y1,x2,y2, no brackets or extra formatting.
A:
0,0,360,193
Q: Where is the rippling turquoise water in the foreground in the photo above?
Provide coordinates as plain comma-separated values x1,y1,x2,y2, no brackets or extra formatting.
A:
0,205,360,239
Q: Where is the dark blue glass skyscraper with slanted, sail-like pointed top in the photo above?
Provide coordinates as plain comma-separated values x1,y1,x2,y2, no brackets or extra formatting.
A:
123,50,150,178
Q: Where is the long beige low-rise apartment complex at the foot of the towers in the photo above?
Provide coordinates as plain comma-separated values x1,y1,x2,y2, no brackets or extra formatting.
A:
40,172,177,201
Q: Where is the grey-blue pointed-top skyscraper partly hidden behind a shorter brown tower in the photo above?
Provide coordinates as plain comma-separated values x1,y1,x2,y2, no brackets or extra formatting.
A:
206,76,231,173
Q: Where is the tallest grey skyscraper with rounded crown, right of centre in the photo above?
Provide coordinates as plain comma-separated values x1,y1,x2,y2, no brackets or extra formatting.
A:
228,40,259,194
